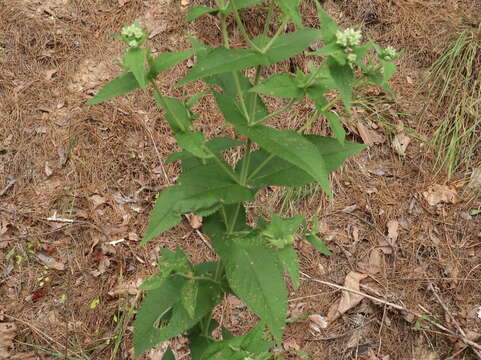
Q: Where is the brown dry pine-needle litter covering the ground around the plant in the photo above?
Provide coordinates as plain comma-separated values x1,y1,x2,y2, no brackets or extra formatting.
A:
0,0,481,360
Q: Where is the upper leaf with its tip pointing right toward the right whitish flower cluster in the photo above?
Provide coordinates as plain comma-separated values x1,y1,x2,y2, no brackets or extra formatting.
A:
253,28,321,65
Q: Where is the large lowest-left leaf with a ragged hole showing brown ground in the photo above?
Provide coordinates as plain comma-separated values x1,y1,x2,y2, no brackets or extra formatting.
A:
134,277,222,356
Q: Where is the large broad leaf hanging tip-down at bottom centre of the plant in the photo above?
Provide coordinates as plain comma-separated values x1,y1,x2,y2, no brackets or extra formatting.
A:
212,232,287,341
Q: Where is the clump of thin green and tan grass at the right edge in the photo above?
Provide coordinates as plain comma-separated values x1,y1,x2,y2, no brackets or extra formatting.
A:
421,25,481,178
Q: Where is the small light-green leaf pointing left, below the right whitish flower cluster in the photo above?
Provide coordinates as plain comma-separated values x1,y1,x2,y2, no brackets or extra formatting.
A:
249,74,304,99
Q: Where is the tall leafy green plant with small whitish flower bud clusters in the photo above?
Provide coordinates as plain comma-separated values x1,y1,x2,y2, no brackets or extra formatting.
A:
88,0,397,359
